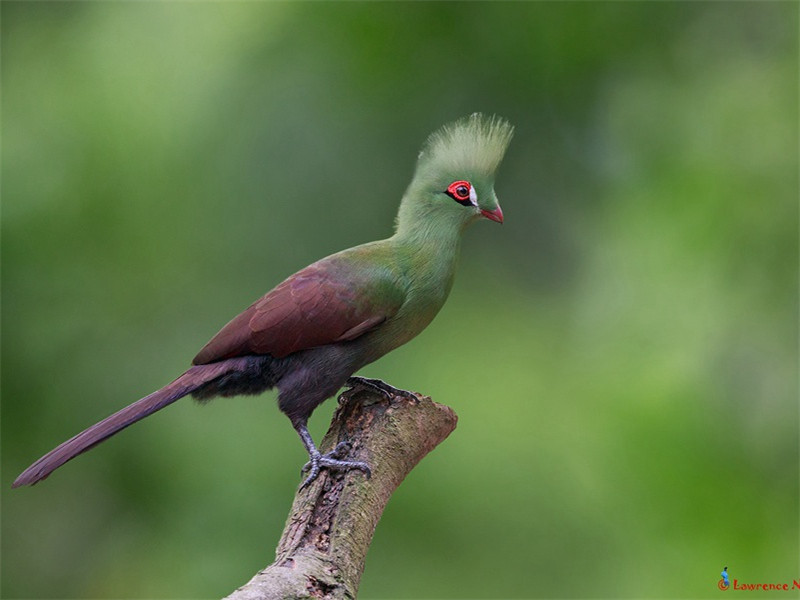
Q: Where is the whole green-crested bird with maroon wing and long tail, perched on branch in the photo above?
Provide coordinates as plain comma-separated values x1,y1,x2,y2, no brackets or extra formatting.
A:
12,113,513,488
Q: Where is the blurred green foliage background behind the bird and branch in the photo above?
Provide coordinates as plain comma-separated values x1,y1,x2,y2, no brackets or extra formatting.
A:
1,2,800,598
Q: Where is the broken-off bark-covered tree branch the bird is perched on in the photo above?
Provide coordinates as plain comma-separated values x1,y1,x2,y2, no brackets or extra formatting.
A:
226,388,457,600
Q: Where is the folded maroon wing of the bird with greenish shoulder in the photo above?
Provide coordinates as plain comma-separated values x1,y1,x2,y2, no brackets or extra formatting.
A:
192,258,404,365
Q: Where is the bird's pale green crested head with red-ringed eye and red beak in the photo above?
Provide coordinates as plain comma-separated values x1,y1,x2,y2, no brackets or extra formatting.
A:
397,113,513,236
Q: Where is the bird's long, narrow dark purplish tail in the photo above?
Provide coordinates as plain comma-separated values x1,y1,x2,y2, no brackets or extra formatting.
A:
11,359,242,488
